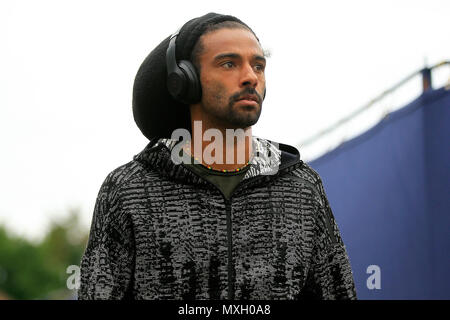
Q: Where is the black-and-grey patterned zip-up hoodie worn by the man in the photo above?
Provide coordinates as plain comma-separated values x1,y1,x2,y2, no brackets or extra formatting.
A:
78,137,356,300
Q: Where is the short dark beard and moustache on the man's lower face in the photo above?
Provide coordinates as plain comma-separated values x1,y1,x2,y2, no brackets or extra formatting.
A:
201,83,263,129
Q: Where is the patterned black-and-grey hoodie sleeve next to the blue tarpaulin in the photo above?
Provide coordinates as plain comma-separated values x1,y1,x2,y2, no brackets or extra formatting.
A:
300,178,357,300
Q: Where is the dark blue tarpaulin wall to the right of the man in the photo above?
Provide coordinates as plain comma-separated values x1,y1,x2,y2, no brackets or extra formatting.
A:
309,88,450,299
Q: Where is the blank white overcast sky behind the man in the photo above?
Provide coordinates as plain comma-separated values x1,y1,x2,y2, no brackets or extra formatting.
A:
0,0,450,238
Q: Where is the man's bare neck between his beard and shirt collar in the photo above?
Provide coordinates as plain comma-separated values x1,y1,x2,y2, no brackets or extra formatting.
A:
190,119,253,171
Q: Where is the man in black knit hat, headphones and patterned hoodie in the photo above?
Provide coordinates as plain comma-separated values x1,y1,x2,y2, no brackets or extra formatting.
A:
78,13,356,299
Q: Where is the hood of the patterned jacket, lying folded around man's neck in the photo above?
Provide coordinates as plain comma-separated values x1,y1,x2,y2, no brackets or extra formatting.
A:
133,136,303,183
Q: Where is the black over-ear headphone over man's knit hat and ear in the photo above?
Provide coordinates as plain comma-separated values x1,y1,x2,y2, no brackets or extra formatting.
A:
166,30,202,104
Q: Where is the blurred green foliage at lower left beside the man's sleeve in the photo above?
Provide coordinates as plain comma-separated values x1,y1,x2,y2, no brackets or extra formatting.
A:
0,209,89,299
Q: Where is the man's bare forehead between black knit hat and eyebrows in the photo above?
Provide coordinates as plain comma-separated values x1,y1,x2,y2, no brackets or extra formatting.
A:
201,28,263,59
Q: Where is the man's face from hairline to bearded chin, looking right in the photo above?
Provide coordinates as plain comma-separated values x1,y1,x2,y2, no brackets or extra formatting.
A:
199,28,266,129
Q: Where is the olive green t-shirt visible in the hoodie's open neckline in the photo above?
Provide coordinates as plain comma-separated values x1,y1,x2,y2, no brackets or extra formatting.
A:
188,163,249,200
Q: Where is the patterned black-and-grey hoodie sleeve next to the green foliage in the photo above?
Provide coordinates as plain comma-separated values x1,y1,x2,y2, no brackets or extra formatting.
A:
78,172,134,300
